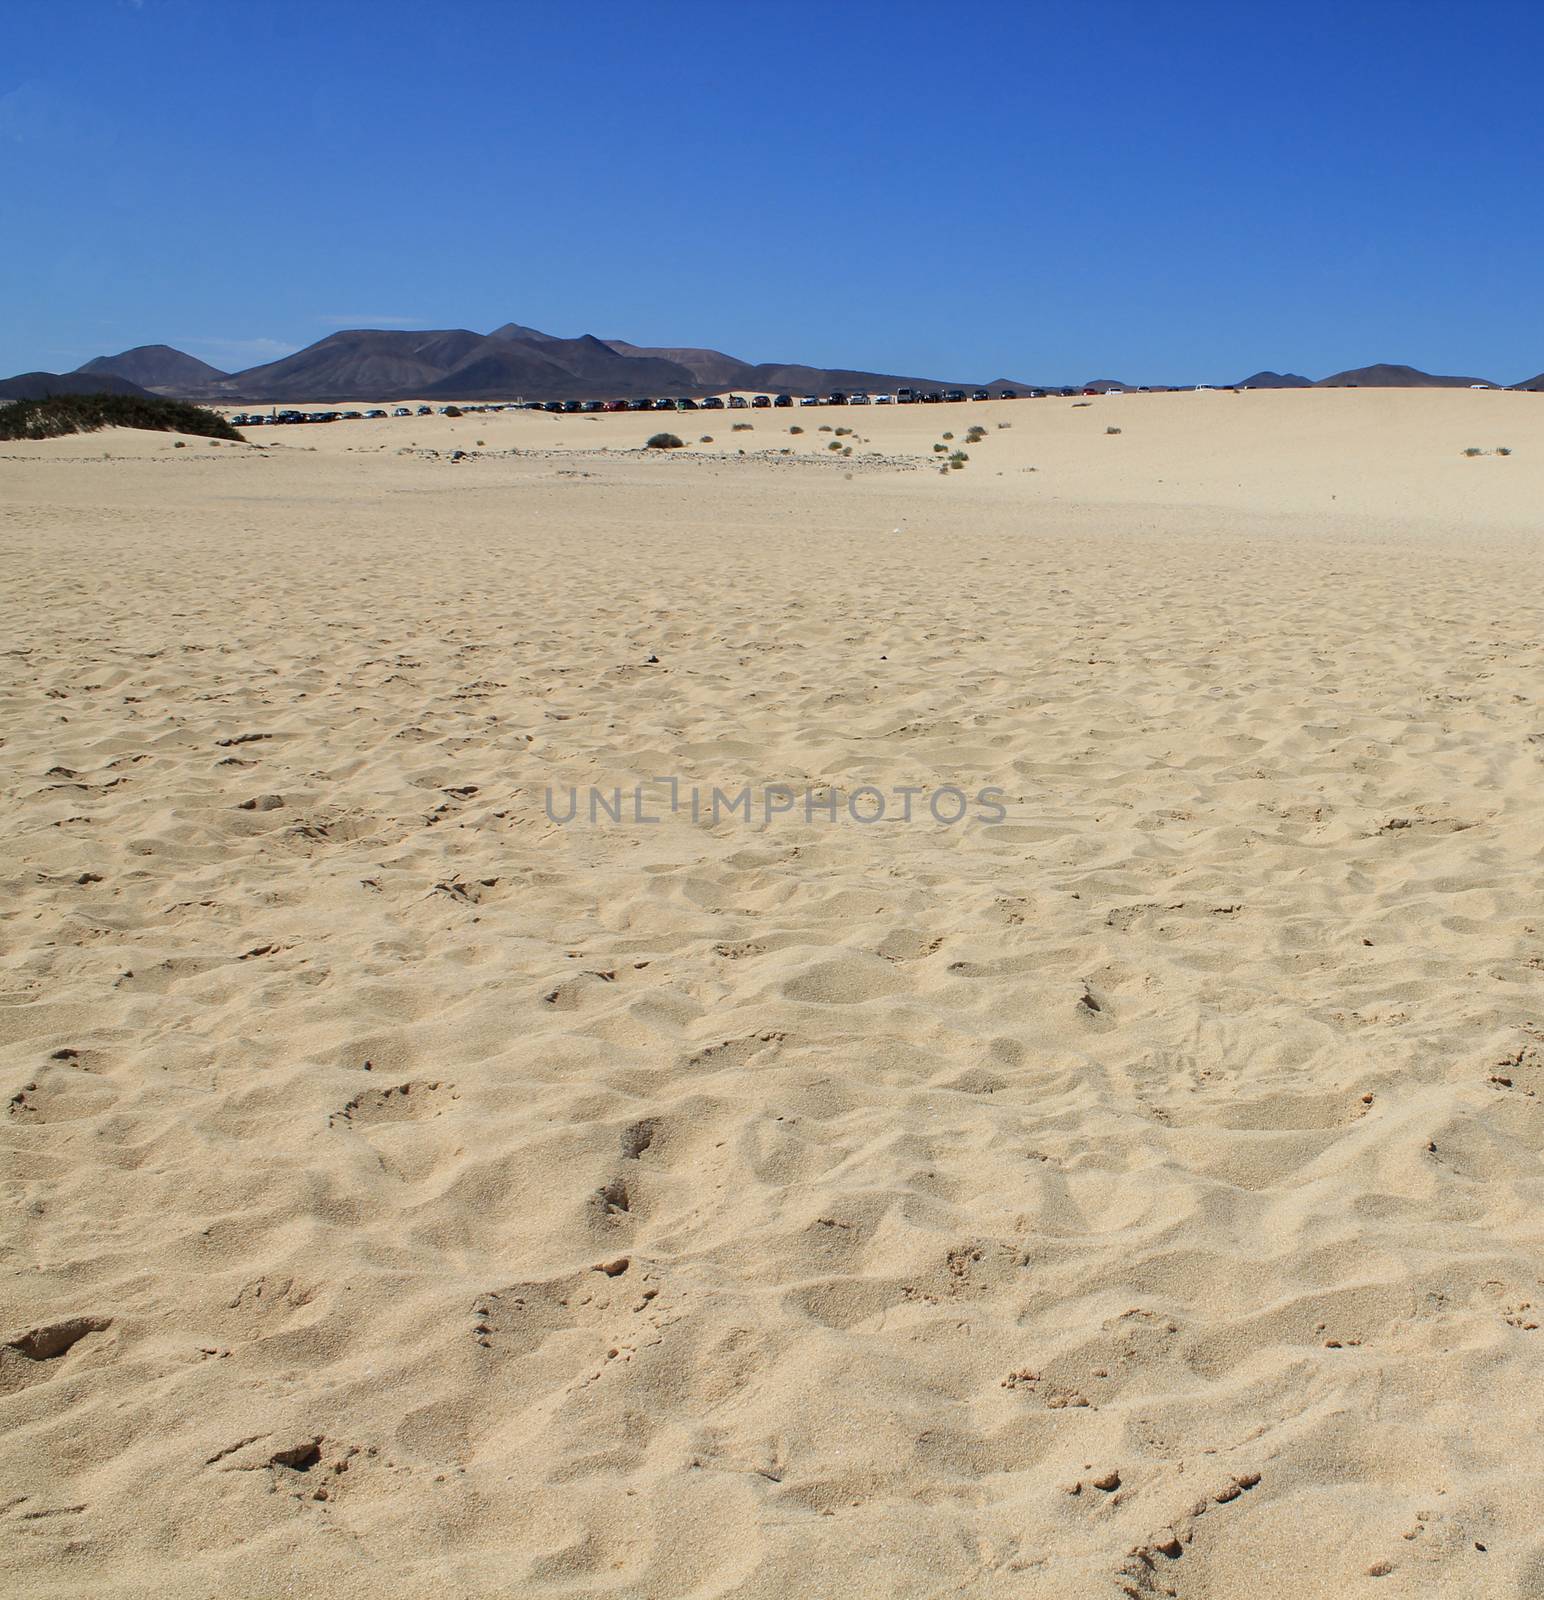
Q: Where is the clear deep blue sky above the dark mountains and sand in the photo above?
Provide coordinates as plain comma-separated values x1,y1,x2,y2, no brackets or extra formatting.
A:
0,0,1544,382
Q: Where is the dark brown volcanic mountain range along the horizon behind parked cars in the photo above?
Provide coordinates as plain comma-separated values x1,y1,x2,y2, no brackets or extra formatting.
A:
0,322,1544,405
